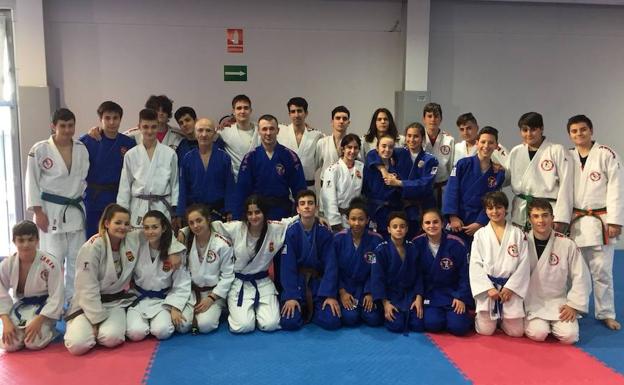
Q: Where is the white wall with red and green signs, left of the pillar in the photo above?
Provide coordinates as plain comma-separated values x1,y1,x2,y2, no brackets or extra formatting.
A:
44,0,403,133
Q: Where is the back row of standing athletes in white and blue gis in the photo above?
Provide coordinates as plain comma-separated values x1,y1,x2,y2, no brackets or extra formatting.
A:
1,91,622,350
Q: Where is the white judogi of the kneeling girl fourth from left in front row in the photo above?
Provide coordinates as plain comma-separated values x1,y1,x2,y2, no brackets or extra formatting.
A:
185,231,234,333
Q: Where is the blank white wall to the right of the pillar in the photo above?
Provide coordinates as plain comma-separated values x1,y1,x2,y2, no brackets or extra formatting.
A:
429,0,624,155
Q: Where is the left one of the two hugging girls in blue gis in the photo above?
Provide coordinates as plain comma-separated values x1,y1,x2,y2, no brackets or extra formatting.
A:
362,135,402,237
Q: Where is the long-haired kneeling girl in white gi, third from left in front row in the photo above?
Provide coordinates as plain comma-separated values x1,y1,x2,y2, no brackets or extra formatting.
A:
126,210,192,341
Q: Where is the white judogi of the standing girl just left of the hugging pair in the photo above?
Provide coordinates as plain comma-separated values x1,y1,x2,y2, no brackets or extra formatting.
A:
321,159,364,228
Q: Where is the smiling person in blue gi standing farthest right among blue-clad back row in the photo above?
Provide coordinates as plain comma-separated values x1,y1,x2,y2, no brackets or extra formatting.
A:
442,126,505,250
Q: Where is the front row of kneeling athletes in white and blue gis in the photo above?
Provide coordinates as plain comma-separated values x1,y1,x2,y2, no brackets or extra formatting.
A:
0,190,590,354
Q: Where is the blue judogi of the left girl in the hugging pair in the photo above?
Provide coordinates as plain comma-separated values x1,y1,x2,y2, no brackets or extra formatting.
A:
362,150,403,237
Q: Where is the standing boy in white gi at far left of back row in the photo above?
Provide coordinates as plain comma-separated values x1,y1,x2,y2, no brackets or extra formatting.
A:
26,108,89,301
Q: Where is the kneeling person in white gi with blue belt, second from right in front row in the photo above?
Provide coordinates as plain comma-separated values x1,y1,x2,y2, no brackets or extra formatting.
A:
469,191,530,337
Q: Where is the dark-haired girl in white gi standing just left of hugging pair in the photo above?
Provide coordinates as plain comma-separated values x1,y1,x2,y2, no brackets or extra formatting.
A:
321,134,364,231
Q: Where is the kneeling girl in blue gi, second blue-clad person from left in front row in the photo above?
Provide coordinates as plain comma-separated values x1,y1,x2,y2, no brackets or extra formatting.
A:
334,198,383,326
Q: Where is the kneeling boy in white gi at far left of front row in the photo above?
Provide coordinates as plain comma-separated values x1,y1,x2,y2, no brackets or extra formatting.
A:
0,221,63,352
